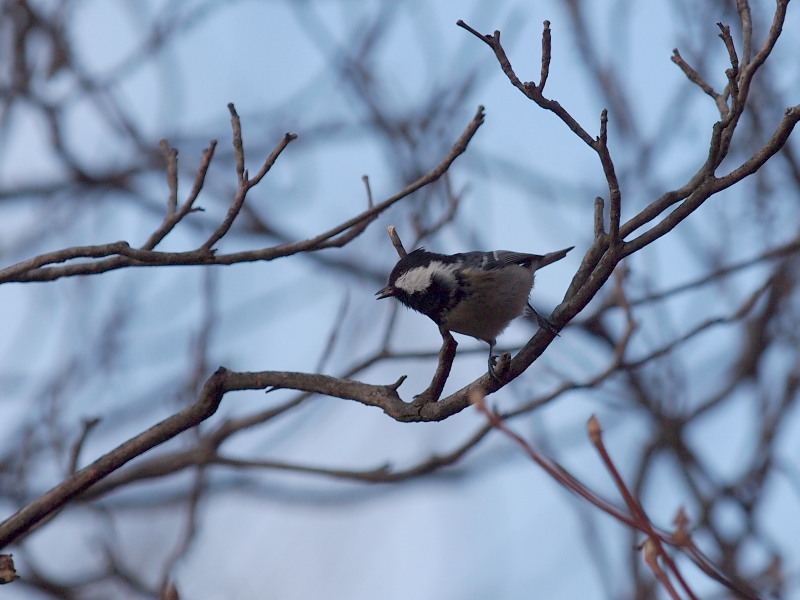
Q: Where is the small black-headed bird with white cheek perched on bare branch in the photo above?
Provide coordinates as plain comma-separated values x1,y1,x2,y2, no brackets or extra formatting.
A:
375,246,574,381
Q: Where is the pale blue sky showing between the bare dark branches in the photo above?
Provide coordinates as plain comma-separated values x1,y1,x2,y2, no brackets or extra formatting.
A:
0,0,800,600
